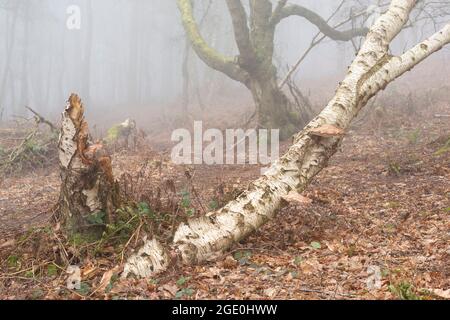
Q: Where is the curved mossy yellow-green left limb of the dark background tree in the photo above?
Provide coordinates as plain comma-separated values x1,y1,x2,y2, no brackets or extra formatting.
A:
177,0,248,84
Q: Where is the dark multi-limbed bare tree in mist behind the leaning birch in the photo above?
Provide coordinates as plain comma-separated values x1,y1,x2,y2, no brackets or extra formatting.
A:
178,0,367,137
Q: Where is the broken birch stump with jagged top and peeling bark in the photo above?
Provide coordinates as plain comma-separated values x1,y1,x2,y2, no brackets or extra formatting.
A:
56,94,119,236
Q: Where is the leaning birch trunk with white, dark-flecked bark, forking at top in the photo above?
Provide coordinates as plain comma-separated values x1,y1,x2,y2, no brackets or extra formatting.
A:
124,0,450,277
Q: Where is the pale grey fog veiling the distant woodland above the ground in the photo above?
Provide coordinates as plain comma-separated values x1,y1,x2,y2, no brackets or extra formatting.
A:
0,0,450,125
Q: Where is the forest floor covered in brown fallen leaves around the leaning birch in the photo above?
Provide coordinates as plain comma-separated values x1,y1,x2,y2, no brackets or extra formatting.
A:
0,105,450,299
